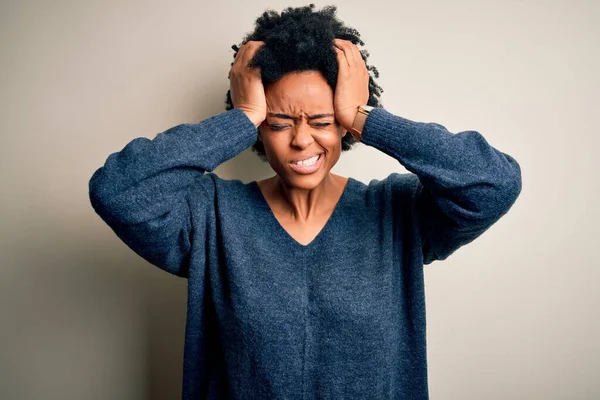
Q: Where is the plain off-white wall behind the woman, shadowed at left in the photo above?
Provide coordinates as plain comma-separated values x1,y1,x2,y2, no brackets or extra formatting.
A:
0,0,600,400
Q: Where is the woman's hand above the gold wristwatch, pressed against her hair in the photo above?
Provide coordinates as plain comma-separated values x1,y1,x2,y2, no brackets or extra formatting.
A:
333,39,369,131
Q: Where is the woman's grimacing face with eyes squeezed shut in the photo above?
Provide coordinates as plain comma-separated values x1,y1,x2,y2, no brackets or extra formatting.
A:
259,71,346,189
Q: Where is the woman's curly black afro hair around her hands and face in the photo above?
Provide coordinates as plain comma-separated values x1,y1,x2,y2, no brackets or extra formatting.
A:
225,4,383,162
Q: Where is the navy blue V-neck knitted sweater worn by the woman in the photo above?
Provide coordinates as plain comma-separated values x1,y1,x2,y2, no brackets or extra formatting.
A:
89,108,521,399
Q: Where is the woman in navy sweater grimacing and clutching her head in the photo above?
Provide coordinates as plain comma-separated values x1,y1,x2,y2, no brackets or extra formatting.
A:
90,5,521,399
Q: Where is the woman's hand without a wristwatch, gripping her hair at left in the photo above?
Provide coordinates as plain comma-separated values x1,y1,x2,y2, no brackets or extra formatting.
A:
229,40,267,128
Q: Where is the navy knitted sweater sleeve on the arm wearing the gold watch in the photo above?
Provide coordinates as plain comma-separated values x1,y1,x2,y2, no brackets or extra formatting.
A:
361,108,521,264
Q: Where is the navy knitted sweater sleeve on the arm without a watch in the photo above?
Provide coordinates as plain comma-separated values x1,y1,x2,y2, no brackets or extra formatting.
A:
89,108,257,277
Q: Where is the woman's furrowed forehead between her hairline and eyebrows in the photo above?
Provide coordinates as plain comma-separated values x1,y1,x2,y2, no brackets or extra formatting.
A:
265,71,333,113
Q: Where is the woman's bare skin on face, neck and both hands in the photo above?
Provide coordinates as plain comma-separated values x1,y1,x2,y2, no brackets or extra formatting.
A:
230,39,369,245
